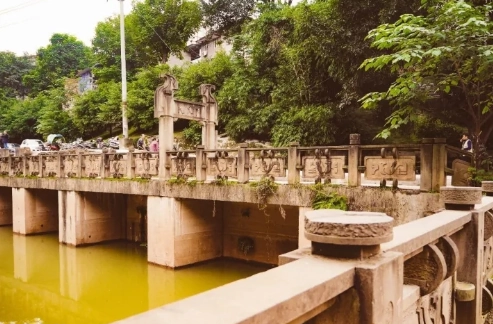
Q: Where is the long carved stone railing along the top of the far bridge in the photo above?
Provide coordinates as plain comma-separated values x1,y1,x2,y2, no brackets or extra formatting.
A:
0,134,467,191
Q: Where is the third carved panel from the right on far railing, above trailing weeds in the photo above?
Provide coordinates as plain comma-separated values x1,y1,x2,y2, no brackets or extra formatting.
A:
250,150,286,178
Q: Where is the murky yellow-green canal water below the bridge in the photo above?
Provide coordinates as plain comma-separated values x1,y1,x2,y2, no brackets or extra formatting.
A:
0,227,267,324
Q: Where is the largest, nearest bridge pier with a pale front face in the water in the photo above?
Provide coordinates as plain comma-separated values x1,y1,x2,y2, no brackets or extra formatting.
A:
147,196,222,268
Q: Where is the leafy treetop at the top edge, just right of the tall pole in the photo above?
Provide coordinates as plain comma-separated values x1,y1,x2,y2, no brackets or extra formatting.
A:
129,0,202,64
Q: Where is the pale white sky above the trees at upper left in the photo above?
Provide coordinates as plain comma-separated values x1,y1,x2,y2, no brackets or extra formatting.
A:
0,0,131,55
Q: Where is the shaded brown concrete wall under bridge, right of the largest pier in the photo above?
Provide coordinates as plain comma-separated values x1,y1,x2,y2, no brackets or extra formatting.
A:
223,203,299,264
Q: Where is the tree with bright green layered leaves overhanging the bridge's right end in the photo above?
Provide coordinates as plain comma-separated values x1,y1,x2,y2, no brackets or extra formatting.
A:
361,1,493,147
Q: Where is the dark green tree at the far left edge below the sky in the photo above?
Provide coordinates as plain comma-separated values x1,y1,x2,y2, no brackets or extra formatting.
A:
0,52,34,98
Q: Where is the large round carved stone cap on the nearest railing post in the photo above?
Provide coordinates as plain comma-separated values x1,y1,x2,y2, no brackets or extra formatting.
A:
305,209,394,246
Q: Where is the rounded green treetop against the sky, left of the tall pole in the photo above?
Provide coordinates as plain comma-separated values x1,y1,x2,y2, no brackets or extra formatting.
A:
23,34,92,94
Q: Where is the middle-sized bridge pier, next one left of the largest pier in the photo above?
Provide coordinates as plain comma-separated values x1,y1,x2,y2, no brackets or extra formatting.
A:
58,191,126,246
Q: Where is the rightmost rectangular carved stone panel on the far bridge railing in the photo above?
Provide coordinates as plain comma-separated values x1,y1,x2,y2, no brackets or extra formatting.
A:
365,156,416,181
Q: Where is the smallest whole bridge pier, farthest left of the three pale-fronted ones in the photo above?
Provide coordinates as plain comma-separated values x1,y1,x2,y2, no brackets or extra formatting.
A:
12,188,58,235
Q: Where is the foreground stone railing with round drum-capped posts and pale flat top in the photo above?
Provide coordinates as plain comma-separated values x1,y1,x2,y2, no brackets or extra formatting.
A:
113,187,493,324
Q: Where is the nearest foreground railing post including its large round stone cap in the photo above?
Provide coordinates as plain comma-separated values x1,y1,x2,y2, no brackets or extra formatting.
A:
305,210,404,324
